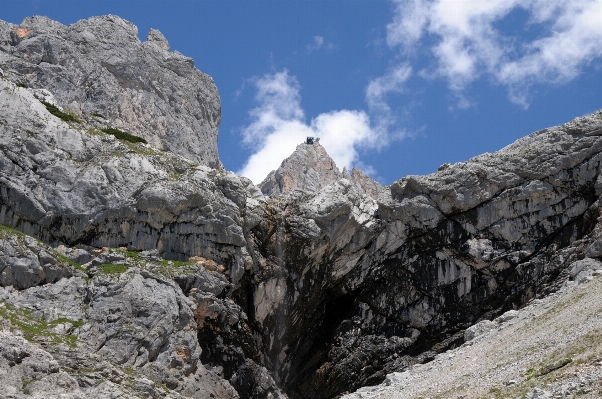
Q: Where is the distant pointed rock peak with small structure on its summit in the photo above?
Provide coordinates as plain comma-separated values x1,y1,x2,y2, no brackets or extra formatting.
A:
259,141,382,198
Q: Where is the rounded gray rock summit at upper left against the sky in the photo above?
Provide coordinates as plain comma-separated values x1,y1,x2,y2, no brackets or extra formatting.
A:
0,15,221,168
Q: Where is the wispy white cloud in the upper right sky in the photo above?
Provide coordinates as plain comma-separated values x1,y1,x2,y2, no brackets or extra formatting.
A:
387,0,602,106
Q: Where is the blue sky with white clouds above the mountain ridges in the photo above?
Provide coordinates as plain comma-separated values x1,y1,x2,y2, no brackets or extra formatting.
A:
0,0,602,184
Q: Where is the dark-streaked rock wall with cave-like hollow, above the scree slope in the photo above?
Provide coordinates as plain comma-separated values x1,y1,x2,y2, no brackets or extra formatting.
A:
245,112,602,398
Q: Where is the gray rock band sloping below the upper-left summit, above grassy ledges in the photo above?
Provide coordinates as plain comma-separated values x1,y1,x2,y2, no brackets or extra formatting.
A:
0,81,255,274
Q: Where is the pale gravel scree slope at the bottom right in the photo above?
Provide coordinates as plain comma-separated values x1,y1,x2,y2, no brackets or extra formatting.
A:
344,259,602,399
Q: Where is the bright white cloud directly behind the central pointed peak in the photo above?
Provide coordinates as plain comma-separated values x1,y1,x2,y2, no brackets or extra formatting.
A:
237,70,380,184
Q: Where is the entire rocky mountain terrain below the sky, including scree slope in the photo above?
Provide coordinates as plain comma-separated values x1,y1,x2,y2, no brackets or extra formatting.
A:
0,15,602,399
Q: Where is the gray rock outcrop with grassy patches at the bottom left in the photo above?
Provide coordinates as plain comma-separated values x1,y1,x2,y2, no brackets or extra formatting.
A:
0,233,244,398
